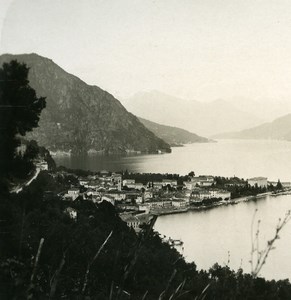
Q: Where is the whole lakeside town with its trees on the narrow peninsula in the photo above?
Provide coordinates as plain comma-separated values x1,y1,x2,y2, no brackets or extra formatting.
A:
37,161,291,232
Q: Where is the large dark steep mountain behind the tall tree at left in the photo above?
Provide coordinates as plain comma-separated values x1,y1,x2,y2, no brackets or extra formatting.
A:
0,54,171,153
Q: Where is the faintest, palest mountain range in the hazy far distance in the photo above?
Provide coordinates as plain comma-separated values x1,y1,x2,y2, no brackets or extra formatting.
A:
122,91,262,136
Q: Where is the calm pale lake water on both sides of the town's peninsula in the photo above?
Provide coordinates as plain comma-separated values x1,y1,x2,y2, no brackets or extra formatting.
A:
55,140,291,279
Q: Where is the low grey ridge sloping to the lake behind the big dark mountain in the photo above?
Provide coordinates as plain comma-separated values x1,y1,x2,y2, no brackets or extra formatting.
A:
139,118,211,146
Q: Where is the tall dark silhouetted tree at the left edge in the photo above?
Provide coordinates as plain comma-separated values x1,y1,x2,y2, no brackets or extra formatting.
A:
0,60,46,190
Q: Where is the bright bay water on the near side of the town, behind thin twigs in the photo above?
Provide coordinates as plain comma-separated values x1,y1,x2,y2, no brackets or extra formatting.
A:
155,195,291,280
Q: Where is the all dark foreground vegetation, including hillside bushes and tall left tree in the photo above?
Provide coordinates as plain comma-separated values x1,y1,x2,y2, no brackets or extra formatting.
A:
0,62,291,300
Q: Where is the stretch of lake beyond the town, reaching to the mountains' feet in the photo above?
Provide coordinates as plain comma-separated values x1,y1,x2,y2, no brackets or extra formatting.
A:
54,140,291,181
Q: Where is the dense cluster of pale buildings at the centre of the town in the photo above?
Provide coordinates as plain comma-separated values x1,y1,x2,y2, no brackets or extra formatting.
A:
63,171,231,213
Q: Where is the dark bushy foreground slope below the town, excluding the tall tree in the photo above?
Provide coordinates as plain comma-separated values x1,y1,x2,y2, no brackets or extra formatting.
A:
0,172,291,299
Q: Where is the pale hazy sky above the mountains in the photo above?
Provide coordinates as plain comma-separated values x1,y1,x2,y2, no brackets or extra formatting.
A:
0,0,291,101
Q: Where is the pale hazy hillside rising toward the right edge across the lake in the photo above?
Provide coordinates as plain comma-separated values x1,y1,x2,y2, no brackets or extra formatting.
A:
215,114,291,141
